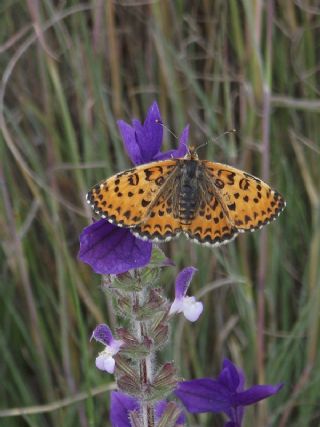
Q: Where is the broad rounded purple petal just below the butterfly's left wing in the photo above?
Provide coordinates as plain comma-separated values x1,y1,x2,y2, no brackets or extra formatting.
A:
78,219,152,274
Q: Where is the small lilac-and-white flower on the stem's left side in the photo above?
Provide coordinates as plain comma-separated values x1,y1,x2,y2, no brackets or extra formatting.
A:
91,324,123,374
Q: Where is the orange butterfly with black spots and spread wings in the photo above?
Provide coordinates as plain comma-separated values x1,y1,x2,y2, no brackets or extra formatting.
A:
87,147,285,246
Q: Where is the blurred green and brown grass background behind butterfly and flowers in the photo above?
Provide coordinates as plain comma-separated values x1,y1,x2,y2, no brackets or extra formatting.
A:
0,0,320,427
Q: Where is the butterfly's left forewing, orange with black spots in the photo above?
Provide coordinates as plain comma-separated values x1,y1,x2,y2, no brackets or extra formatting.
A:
87,159,176,227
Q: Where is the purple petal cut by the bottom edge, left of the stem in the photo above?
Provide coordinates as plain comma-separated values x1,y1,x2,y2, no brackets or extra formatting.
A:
110,391,139,427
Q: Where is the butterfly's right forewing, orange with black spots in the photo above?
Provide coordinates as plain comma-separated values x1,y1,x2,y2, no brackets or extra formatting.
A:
203,161,285,231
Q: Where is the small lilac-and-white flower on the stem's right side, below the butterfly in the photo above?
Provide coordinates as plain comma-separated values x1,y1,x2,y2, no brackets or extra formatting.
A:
169,267,203,322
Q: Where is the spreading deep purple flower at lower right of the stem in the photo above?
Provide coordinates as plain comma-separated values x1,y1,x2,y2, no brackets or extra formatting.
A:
175,359,283,427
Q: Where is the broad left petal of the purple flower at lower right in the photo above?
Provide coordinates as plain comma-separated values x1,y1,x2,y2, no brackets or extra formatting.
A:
175,378,231,413
